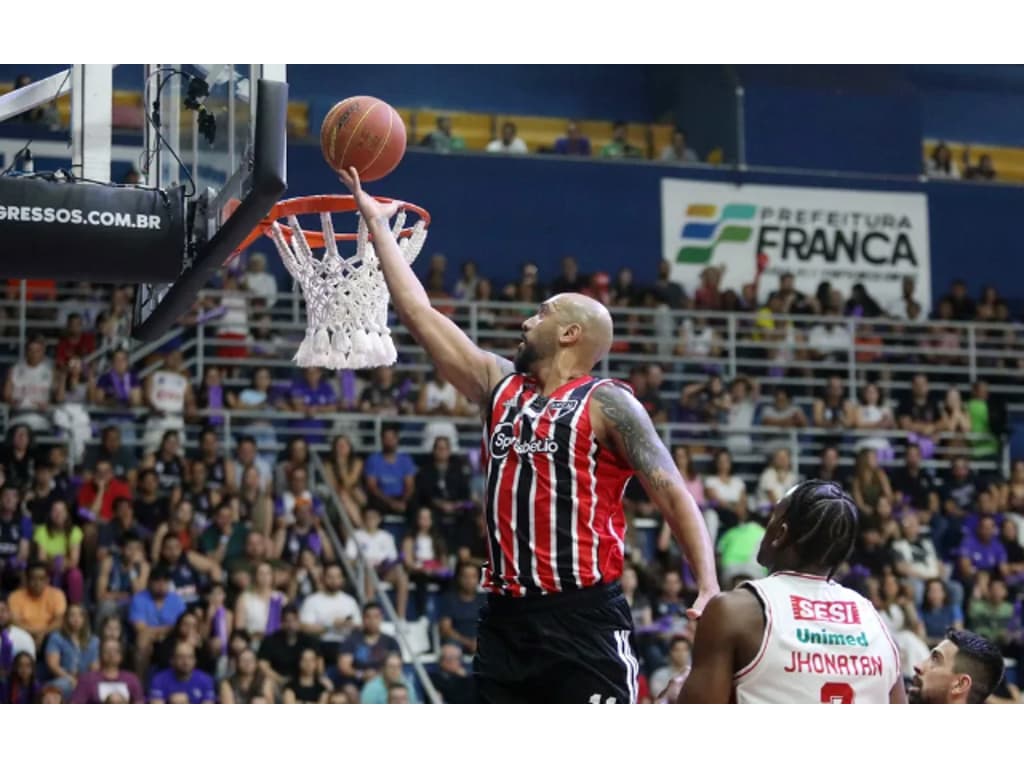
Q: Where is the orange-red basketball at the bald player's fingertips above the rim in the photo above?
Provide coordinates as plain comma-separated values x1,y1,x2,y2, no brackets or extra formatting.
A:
321,96,406,181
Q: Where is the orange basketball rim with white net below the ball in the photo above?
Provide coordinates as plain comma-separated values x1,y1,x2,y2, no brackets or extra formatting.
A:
238,195,430,370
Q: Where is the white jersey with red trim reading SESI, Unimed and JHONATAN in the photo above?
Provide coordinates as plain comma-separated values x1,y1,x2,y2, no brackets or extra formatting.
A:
733,571,902,703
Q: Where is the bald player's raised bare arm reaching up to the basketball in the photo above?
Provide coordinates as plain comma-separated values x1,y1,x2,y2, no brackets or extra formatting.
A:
341,168,513,403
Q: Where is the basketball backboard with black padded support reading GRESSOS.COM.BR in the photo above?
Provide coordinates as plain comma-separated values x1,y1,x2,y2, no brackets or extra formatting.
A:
0,65,288,340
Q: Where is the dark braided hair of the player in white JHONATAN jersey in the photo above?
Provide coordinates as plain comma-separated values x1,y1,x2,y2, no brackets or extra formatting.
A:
783,480,860,579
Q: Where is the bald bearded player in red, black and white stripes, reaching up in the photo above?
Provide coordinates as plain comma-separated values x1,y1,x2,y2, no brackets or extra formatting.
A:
341,169,718,703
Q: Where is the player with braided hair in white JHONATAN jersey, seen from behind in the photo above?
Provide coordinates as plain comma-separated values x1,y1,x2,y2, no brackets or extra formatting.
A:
669,480,906,703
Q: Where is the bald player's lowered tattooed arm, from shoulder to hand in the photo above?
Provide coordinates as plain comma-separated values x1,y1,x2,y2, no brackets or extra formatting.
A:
591,385,719,618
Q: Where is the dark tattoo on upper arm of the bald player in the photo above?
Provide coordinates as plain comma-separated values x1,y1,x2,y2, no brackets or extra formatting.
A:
594,384,676,490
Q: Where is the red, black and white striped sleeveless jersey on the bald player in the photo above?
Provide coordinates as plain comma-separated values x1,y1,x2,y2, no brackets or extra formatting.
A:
483,374,633,597
